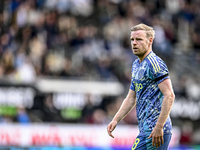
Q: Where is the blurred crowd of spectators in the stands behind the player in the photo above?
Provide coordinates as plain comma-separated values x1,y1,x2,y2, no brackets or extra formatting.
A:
0,0,200,145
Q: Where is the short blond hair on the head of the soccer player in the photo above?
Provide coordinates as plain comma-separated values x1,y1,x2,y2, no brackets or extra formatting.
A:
131,23,155,39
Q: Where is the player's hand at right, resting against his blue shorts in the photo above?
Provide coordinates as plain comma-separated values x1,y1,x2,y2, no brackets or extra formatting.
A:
148,126,164,148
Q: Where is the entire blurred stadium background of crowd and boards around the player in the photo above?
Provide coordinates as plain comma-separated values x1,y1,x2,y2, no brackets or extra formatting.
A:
0,0,200,150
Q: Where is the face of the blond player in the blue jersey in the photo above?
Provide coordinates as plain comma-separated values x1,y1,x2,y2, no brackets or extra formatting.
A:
130,30,151,57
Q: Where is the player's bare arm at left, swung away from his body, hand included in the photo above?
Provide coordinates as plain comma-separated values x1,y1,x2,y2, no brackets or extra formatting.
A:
107,89,136,138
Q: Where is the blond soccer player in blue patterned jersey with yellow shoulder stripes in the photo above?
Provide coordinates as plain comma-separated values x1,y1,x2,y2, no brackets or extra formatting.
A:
107,24,175,150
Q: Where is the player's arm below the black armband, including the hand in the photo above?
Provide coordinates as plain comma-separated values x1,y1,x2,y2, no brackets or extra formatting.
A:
149,78,175,147
